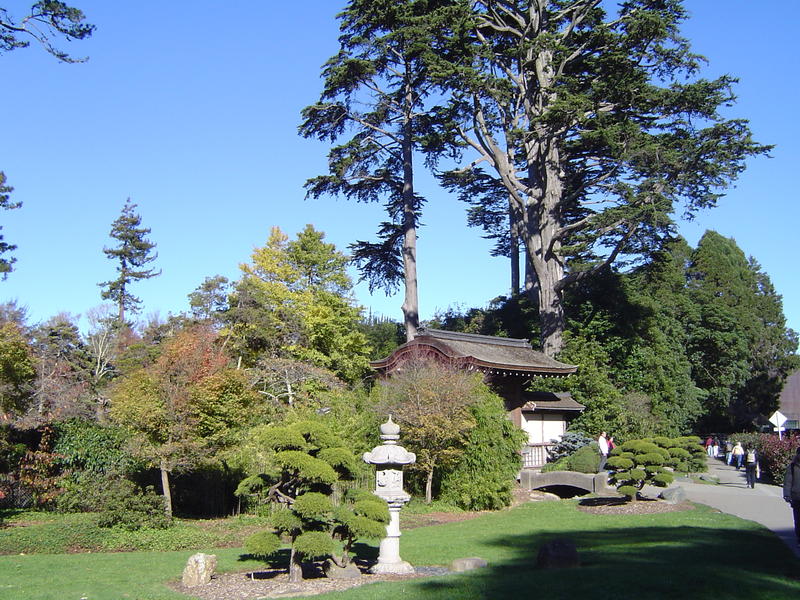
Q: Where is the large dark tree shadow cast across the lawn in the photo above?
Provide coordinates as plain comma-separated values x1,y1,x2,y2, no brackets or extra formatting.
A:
406,526,800,600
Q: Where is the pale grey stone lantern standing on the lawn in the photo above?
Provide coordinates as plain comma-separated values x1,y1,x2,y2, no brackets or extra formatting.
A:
364,415,417,574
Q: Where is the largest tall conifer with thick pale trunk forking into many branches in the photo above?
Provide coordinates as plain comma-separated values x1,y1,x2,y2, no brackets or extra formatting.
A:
442,0,769,355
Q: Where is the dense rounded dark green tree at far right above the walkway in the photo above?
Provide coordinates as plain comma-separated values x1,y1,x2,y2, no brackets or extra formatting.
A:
688,231,797,430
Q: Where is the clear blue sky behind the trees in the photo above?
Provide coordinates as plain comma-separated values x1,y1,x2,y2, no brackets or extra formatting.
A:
0,0,800,338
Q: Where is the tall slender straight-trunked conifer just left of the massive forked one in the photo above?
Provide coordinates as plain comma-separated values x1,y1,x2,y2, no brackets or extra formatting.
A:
300,0,460,340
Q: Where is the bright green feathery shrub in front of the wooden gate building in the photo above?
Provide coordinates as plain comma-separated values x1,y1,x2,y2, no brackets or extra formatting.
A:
440,390,526,510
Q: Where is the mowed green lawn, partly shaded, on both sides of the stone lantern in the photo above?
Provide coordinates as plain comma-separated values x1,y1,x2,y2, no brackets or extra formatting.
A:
0,501,800,600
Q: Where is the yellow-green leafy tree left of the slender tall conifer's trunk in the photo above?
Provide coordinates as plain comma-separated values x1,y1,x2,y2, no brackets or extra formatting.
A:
223,225,369,382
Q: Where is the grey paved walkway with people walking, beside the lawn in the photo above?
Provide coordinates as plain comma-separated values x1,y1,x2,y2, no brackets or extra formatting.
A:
660,459,800,558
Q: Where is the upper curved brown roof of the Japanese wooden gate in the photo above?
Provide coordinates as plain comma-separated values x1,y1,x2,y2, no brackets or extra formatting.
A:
370,327,578,377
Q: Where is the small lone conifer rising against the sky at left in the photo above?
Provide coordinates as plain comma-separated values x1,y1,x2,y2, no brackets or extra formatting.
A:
98,198,161,323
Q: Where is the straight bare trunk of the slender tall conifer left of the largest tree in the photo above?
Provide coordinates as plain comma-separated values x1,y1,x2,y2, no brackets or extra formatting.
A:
402,67,419,342
